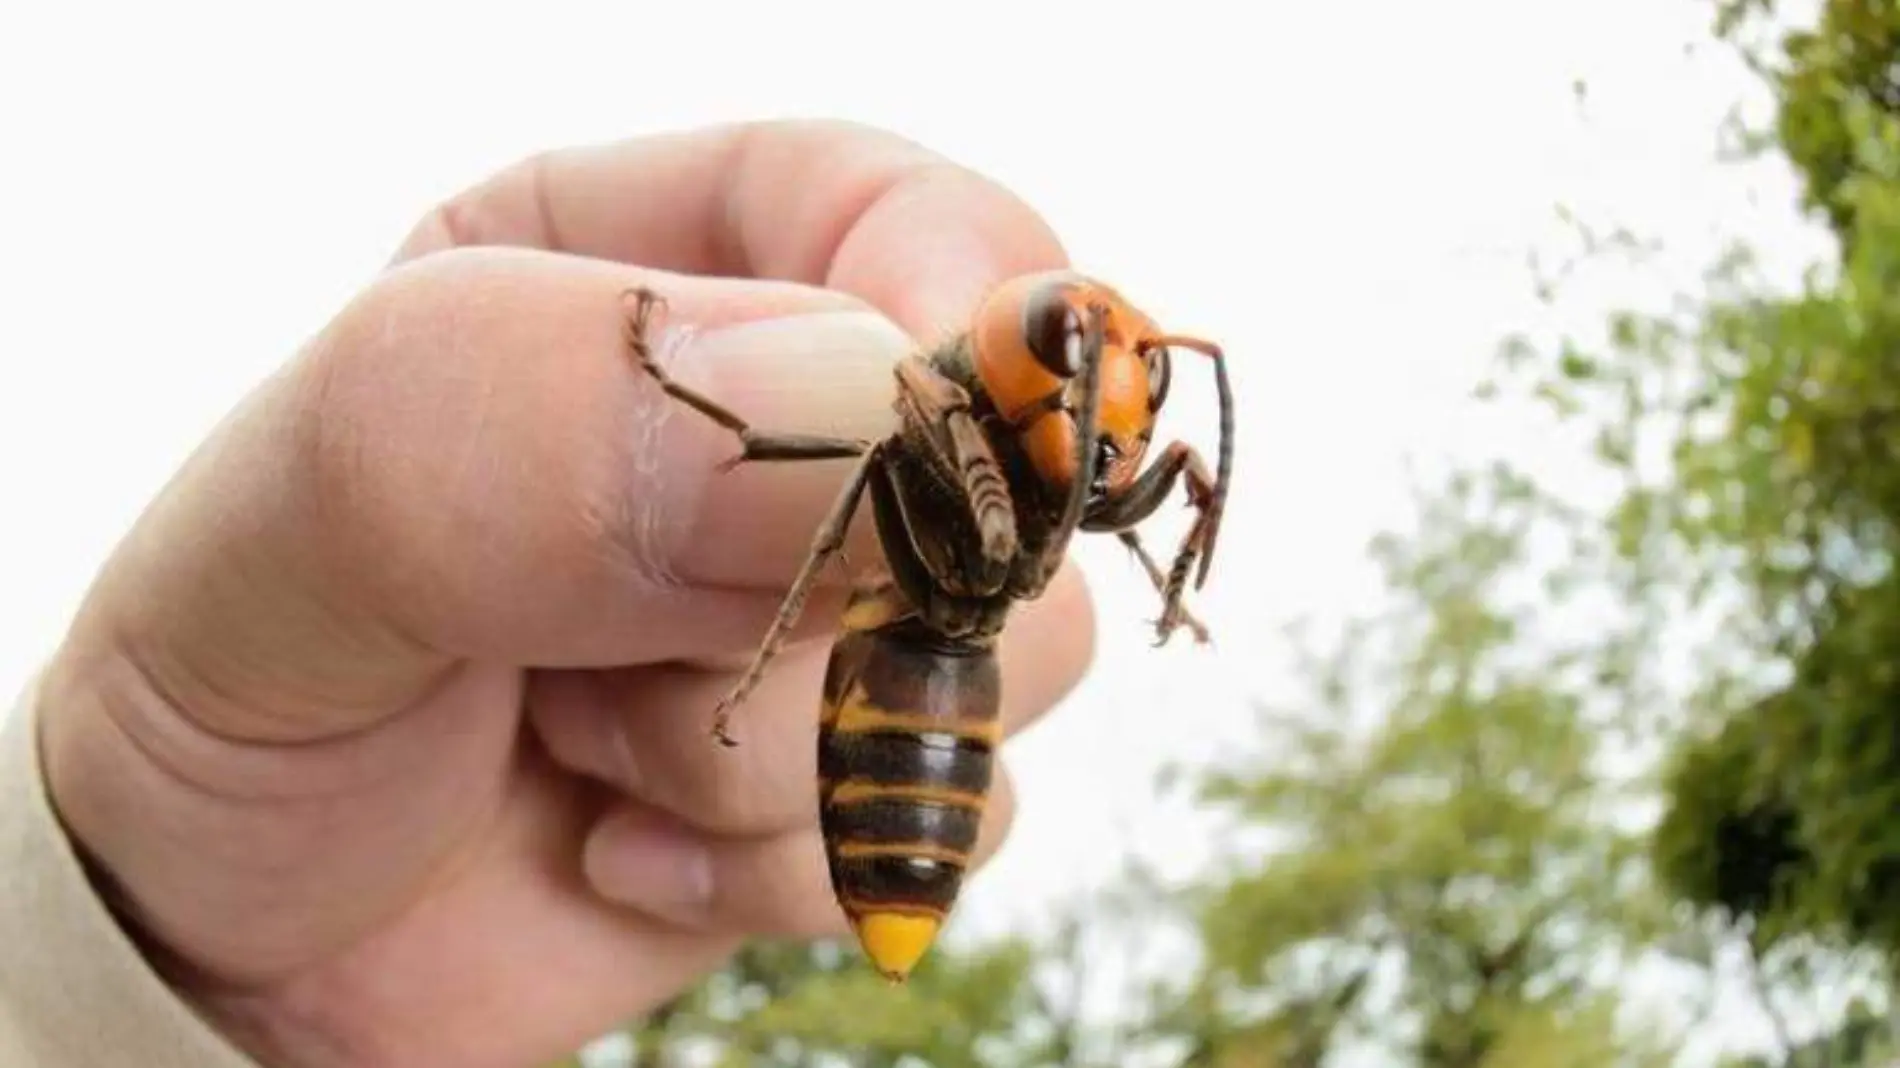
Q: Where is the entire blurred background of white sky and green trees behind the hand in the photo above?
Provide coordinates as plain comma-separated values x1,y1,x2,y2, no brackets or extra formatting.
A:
0,0,1900,1068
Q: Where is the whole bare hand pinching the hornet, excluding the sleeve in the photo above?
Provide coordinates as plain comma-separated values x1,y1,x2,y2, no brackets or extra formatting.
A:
42,124,1093,1068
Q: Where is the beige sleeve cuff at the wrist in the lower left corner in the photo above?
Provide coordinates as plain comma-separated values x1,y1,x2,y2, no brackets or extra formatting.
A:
0,676,258,1068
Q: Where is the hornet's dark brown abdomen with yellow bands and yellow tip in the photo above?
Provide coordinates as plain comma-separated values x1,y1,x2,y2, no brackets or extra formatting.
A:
819,585,1001,979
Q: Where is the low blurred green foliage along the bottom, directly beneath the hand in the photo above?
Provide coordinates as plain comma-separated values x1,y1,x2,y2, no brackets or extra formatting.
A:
608,865,1193,1068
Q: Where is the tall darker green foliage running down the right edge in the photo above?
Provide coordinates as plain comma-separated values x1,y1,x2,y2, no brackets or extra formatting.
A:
1518,0,1900,958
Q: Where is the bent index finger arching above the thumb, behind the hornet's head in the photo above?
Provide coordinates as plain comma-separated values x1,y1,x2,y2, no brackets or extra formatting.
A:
397,122,1068,340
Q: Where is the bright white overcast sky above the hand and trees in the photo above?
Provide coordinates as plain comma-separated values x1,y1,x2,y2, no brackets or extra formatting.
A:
0,0,1839,1056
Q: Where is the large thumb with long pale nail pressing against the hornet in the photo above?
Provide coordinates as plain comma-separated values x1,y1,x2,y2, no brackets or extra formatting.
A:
49,249,910,741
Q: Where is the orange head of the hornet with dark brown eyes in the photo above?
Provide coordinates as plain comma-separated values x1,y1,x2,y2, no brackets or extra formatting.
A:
971,272,1170,498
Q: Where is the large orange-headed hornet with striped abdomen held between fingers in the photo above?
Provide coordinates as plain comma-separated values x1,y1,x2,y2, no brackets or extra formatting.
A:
627,272,1233,981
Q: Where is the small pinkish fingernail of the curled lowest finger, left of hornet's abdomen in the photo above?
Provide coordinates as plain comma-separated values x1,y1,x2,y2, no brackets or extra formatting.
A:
581,810,713,924
